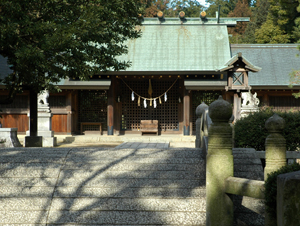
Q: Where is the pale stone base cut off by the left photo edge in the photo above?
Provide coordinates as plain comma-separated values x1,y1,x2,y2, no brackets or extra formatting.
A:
0,128,22,148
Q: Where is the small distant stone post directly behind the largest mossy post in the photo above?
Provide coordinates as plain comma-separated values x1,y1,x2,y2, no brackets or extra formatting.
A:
195,102,208,148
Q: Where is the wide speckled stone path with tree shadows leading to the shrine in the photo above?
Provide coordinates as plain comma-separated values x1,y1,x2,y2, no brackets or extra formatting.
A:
0,146,205,226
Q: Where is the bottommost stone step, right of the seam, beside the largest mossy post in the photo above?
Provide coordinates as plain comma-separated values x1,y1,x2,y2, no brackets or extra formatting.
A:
48,211,205,226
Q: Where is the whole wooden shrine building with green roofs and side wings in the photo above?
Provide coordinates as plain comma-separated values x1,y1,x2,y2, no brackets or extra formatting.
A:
0,13,300,135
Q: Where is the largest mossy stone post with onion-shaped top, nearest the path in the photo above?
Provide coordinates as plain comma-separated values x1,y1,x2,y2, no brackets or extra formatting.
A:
206,96,233,226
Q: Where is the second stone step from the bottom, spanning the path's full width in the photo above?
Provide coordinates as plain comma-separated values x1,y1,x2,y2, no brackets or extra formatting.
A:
0,197,206,212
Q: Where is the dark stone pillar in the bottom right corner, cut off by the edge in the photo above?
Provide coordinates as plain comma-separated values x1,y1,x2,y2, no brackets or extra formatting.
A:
277,171,300,226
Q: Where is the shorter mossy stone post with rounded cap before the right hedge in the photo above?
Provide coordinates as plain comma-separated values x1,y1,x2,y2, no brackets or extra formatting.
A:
264,114,286,226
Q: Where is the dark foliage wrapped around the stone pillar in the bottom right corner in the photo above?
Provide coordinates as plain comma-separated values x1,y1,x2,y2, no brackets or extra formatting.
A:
264,163,300,219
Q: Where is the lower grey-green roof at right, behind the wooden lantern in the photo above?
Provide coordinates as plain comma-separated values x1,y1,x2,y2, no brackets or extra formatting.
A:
231,44,300,88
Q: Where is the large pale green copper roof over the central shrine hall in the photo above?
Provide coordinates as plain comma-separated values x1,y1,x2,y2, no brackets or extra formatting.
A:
120,19,231,72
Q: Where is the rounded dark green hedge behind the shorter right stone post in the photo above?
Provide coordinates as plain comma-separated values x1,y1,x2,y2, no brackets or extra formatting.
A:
234,108,300,151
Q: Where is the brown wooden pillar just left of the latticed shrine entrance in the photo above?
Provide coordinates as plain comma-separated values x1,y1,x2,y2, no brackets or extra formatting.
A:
107,78,116,135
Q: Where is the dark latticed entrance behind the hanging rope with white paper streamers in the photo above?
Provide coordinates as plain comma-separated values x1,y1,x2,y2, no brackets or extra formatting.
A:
118,78,182,133
